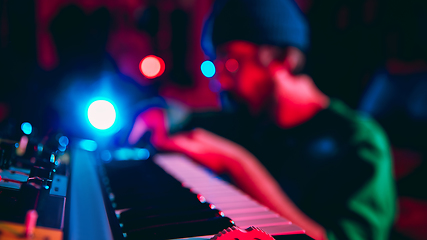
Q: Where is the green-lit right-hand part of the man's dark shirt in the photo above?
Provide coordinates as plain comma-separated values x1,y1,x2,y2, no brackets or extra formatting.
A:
327,115,396,240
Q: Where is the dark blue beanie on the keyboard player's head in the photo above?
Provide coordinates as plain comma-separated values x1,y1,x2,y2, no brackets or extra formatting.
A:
202,0,309,58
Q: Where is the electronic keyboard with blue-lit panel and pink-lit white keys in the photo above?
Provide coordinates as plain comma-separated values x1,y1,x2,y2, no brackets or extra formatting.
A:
69,144,311,240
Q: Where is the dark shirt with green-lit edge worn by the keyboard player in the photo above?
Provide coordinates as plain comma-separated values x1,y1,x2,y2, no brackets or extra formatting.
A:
179,99,396,240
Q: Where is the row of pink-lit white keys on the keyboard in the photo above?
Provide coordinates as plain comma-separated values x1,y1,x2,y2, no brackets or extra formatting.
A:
155,154,304,235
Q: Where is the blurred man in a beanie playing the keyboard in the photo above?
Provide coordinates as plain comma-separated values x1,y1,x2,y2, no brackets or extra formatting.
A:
129,0,395,240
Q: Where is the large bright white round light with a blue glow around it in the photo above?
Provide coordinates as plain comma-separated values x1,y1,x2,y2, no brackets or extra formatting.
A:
88,100,116,130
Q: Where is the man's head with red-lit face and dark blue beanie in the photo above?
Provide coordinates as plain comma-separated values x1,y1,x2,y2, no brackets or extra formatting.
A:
202,0,309,113
